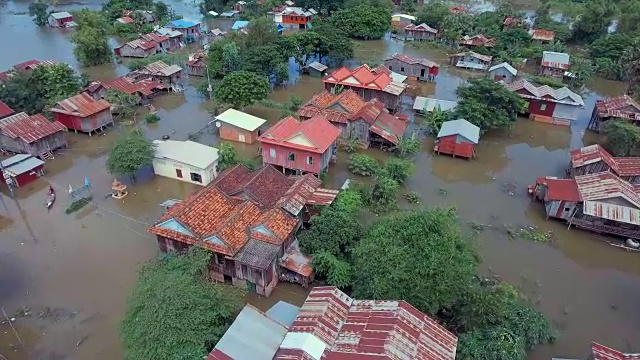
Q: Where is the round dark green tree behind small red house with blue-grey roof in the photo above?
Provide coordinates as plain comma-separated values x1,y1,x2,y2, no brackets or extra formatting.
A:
455,78,526,133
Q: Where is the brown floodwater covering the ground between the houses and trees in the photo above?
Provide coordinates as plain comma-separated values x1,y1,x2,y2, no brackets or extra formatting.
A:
0,1,640,360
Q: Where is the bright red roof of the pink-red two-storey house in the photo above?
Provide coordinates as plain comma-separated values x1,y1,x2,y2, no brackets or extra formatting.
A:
258,115,340,154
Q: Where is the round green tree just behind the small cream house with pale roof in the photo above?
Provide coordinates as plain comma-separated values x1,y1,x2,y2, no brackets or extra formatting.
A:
215,71,269,109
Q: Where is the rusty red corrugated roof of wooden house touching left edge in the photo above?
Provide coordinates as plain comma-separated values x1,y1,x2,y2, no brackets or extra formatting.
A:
0,112,67,144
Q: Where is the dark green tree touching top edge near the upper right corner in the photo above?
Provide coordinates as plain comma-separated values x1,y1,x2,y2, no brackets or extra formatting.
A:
573,0,615,42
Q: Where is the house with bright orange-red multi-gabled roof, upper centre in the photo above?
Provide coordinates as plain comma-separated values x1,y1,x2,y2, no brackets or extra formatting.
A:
322,64,407,111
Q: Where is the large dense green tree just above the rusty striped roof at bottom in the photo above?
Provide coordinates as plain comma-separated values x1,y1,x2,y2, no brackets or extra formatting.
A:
353,208,478,315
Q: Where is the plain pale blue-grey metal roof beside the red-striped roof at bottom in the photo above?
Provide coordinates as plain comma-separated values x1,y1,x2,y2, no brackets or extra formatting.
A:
207,305,287,360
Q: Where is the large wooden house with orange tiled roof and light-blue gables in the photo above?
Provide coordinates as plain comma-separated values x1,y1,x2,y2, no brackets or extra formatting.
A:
149,184,300,296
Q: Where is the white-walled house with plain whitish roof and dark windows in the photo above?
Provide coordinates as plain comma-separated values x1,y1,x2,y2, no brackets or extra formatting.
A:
153,140,218,185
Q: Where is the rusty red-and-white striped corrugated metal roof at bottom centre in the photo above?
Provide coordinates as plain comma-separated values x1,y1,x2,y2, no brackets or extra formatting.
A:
274,287,458,360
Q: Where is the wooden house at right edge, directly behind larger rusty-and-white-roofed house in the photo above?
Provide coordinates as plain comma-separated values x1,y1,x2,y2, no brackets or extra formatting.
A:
568,144,640,185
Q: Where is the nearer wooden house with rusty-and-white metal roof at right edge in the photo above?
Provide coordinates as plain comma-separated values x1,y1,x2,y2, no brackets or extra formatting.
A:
529,171,640,240
